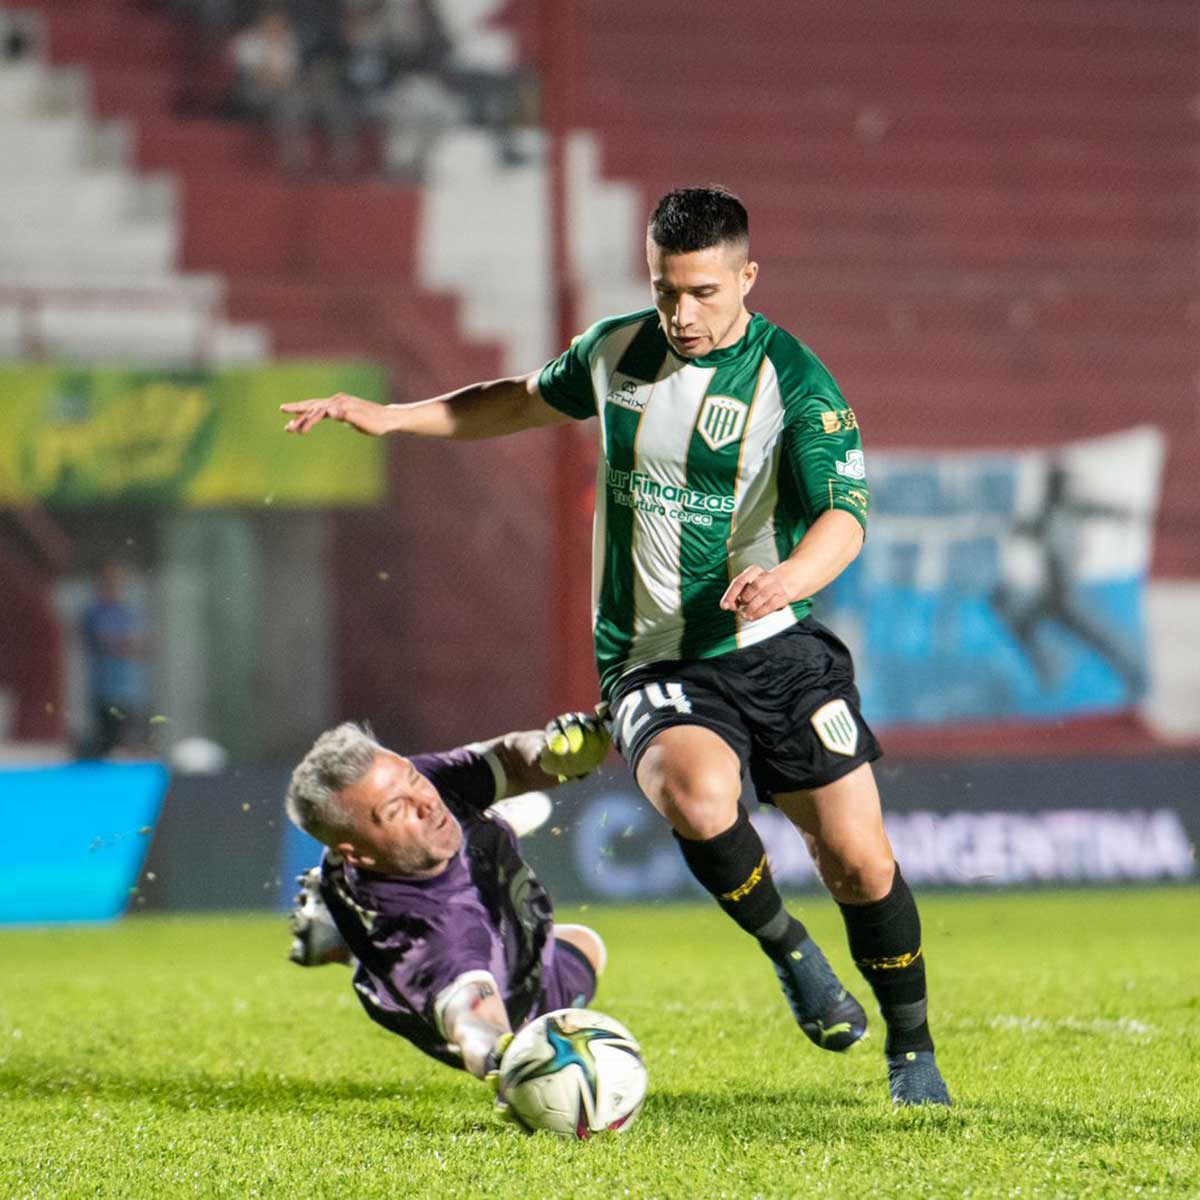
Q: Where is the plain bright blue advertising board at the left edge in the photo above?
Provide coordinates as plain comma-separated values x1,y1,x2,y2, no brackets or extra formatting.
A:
0,762,168,924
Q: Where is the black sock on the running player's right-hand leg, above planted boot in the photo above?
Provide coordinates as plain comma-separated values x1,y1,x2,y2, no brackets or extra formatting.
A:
839,864,934,1054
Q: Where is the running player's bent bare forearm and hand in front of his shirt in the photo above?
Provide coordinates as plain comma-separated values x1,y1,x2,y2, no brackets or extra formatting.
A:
721,509,863,620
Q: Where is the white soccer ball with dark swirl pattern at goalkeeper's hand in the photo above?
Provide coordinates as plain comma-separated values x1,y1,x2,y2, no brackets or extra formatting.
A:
500,1008,646,1139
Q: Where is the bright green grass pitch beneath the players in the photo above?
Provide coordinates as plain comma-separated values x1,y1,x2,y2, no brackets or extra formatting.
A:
0,888,1200,1200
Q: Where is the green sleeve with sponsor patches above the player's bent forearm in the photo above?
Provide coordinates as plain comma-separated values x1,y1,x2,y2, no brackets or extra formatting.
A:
767,329,871,529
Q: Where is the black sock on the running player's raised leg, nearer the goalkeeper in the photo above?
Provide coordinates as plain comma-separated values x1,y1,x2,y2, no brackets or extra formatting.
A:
676,804,809,958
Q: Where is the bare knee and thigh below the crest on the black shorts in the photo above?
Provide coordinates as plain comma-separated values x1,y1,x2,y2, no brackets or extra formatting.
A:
774,762,895,904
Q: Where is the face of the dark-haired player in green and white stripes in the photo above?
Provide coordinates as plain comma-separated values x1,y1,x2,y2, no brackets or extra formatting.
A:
646,238,758,359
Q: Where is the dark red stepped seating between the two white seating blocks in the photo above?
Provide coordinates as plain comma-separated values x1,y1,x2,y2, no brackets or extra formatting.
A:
17,0,504,396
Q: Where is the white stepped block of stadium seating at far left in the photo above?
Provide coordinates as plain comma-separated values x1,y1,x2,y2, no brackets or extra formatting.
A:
0,11,268,364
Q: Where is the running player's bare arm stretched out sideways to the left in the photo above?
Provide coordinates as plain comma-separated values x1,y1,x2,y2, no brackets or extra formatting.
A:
280,372,570,440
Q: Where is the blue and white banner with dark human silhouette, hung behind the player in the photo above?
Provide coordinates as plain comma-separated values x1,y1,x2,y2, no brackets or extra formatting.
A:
816,427,1163,727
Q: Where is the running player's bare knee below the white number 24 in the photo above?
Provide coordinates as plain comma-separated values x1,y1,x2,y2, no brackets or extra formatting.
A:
637,725,742,841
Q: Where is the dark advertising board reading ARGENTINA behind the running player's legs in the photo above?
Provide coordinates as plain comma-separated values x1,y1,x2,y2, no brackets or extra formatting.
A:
523,756,1200,902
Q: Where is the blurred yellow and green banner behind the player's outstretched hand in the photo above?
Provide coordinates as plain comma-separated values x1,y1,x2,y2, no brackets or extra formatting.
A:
0,362,386,508
